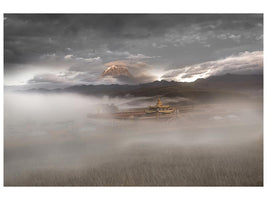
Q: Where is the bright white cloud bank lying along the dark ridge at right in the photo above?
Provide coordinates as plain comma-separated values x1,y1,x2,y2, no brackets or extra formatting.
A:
162,51,263,82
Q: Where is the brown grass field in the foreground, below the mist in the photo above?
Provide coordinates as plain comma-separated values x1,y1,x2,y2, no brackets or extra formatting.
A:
5,147,263,186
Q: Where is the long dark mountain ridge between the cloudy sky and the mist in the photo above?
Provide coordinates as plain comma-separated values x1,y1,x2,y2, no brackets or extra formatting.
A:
24,74,263,99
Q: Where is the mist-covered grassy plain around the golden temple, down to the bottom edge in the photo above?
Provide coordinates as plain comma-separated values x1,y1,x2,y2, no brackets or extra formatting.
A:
4,92,263,186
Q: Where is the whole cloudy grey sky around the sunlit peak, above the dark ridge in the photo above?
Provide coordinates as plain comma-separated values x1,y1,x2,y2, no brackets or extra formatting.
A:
4,14,263,88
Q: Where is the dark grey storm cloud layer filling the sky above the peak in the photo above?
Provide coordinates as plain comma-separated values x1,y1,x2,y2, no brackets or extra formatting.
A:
4,14,263,86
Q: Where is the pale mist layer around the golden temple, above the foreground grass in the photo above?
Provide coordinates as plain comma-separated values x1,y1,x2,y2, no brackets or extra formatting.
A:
4,93,263,185
